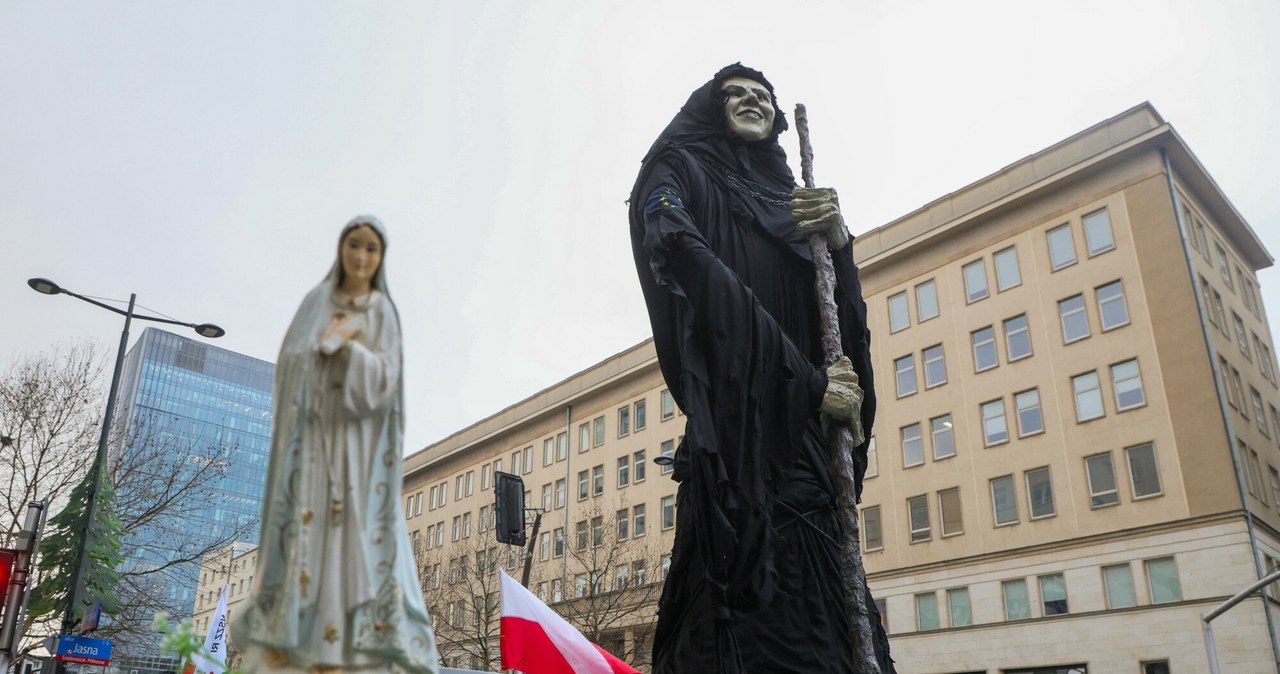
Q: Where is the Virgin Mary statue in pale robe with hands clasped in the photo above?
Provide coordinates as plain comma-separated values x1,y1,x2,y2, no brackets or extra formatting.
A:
232,216,436,674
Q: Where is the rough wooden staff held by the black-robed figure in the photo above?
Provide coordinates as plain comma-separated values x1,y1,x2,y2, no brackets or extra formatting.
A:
796,104,881,674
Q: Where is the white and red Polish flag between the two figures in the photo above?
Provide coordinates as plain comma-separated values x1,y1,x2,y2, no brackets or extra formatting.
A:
498,568,640,674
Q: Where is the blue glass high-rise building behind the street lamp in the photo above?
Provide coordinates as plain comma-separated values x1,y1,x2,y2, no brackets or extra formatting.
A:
111,327,275,670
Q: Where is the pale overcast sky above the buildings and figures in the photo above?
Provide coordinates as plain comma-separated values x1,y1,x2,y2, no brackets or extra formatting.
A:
0,0,1280,451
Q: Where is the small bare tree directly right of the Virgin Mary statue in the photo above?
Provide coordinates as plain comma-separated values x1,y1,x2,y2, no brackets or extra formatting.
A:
415,531,515,671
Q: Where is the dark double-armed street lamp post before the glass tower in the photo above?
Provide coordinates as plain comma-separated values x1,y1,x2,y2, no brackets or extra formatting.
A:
27,279,227,671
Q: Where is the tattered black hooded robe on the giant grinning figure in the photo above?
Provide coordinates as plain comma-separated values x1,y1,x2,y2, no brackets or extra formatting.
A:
630,65,891,674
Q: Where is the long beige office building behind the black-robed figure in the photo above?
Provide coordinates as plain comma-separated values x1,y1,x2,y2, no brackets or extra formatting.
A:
404,105,1280,674
